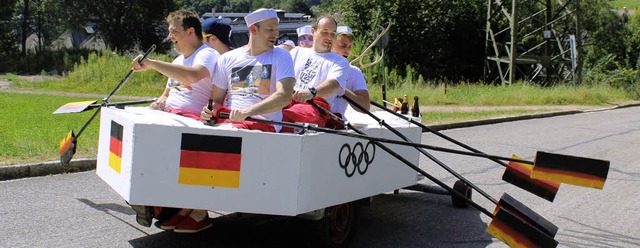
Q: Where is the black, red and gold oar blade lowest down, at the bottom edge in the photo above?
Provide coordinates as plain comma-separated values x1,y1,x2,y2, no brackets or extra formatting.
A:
486,194,558,247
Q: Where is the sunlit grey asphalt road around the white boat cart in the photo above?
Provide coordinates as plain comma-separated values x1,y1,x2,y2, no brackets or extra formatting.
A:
0,107,640,247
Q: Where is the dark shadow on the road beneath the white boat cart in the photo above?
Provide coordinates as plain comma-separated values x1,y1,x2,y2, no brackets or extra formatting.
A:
129,191,493,247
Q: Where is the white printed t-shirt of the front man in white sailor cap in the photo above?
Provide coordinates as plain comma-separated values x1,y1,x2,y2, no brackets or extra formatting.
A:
213,47,294,131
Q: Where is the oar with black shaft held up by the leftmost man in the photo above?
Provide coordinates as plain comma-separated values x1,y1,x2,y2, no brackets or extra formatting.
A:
60,44,156,165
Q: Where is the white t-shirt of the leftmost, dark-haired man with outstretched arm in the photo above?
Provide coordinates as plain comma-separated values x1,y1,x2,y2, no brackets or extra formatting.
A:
166,44,220,115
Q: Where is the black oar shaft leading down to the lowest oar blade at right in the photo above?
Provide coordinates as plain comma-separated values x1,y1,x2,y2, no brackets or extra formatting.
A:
308,100,495,218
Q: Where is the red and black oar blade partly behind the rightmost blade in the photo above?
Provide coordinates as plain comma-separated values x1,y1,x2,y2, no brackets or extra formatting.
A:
502,155,560,202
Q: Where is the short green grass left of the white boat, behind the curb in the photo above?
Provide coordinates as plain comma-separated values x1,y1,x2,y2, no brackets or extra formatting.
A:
0,92,146,165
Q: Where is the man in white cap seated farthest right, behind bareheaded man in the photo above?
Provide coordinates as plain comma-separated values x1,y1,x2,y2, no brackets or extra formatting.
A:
331,26,370,117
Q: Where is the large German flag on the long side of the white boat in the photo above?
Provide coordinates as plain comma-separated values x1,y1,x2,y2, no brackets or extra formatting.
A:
178,133,242,188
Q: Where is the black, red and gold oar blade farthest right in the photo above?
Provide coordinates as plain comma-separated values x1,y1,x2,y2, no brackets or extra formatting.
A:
531,151,610,189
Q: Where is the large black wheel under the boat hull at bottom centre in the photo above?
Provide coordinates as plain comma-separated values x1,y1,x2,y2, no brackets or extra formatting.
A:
315,202,357,247
